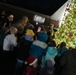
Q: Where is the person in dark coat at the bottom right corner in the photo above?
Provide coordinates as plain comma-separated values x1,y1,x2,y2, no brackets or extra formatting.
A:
60,49,76,75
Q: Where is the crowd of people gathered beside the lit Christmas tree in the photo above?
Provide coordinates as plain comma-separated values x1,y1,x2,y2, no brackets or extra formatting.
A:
0,11,76,75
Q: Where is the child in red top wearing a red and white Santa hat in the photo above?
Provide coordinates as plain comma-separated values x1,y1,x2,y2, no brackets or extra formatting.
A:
24,56,38,75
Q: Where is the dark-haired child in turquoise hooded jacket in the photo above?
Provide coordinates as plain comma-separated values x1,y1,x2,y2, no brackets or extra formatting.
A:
41,40,57,67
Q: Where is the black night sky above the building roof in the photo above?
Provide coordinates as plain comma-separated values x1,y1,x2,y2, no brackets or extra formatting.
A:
0,0,67,15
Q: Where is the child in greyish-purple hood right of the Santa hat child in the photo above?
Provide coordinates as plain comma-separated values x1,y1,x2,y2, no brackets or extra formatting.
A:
39,59,55,75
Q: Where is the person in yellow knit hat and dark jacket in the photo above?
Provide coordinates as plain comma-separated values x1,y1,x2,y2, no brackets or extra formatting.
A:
15,30,34,75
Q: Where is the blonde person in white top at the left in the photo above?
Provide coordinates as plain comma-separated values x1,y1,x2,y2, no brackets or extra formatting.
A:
1,27,18,75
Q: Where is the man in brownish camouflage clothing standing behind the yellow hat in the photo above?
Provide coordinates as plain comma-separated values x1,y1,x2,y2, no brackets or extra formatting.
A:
14,16,28,40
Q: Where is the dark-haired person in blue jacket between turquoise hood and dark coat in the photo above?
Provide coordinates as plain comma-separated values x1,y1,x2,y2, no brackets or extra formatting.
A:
54,42,68,75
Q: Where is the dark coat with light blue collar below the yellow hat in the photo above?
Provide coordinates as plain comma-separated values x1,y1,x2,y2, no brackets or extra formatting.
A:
17,36,32,61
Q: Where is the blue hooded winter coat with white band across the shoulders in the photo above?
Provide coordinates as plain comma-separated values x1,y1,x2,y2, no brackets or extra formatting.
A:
30,32,48,61
